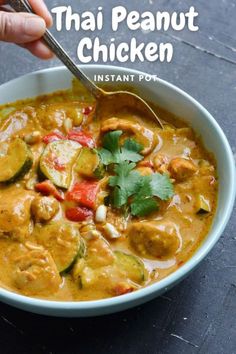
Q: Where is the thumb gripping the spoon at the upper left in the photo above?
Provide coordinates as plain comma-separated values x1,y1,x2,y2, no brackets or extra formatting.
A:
0,11,46,44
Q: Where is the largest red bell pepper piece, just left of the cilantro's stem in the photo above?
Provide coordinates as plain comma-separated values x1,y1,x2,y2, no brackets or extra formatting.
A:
66,181,99,209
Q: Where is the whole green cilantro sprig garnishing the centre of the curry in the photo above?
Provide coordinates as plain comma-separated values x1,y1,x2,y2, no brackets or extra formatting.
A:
98,130,174,216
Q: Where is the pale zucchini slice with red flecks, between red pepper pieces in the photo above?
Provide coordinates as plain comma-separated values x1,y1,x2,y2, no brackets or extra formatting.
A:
40,140,81,189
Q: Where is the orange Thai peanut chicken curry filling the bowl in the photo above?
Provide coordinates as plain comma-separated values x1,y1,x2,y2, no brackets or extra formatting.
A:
0,83,217,301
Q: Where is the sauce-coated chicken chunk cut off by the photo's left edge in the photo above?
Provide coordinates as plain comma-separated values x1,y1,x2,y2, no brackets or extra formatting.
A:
0,187,34,241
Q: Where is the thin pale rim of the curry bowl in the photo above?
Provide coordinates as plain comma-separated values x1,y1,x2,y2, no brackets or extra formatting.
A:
0,64,236,315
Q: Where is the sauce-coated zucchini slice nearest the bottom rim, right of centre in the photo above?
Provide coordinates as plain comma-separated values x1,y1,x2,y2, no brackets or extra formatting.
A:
114,251,146,284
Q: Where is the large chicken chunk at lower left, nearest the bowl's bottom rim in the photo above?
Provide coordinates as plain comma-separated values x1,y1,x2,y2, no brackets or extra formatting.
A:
14,246,61,296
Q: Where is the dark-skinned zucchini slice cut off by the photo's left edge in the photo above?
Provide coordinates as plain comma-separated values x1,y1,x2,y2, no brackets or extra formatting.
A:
0,138,33,183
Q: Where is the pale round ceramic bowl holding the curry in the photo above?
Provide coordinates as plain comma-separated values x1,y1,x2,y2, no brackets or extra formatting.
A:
0,65,236,317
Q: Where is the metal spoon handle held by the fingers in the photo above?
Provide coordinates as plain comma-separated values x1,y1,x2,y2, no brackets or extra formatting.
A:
8,0,103,99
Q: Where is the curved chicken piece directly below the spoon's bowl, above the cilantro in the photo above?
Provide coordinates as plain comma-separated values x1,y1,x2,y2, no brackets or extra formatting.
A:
101,118,157,155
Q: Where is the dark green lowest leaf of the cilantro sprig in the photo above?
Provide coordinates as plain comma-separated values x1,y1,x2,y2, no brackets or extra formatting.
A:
130,197,159,216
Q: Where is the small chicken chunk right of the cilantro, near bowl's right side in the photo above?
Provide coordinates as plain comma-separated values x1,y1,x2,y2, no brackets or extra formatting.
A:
168,157,197,181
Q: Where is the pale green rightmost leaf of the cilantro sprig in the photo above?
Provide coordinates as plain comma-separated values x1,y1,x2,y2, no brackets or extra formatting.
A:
150,173,174,200
